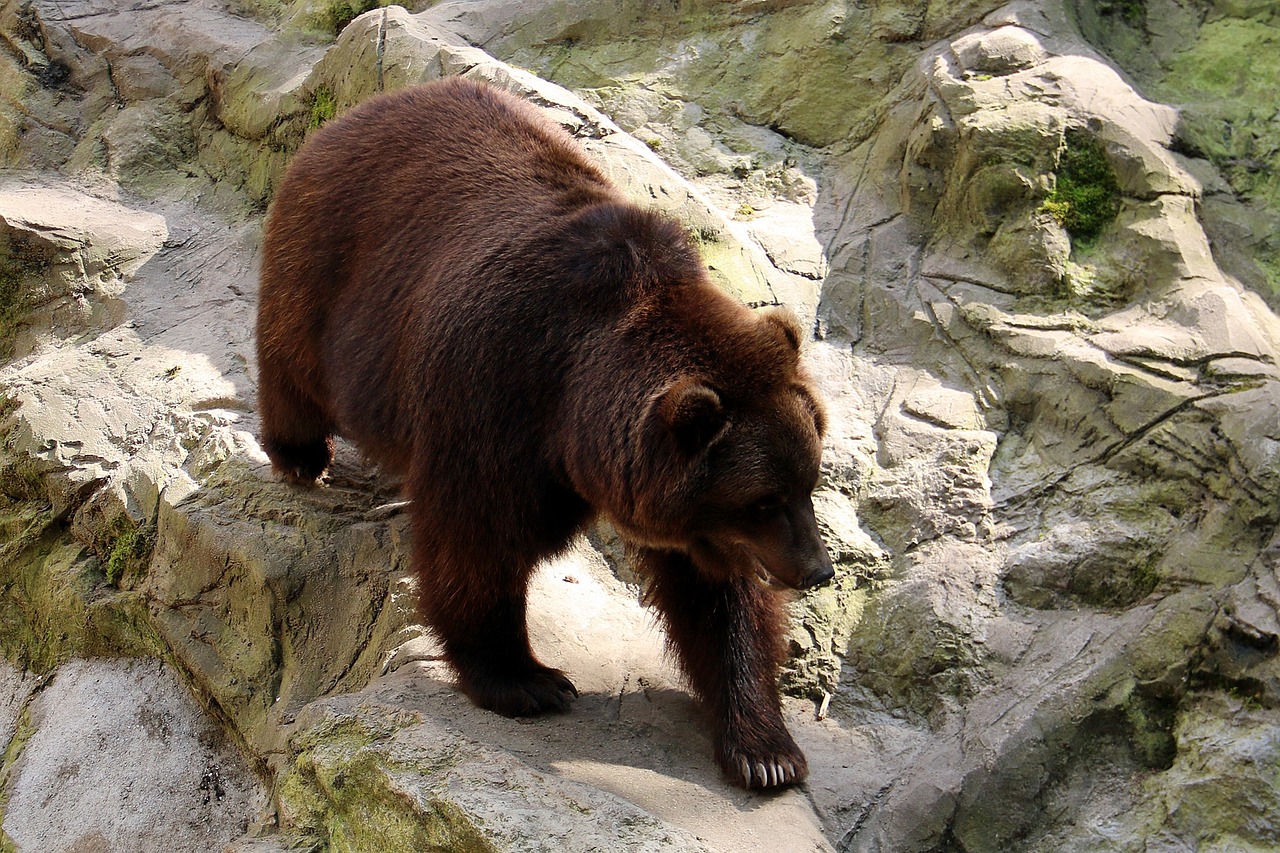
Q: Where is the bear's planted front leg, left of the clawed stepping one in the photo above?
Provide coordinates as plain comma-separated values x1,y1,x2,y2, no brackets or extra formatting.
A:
413,535,577,717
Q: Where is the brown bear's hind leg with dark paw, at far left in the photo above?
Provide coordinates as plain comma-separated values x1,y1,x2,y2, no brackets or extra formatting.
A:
257,361,333,485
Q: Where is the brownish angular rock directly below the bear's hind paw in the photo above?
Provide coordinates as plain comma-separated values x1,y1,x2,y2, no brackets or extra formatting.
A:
141,451,413,771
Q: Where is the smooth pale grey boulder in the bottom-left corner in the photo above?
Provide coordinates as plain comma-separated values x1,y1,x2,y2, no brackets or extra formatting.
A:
4,650,266,853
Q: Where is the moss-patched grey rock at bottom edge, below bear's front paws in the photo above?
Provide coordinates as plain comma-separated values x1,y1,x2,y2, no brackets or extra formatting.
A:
283,699,707,853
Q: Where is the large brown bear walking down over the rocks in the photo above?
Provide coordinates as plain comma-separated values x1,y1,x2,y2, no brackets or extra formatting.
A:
257,78,832,788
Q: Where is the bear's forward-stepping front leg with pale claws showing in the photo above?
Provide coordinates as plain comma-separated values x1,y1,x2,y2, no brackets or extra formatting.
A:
639,549,809,788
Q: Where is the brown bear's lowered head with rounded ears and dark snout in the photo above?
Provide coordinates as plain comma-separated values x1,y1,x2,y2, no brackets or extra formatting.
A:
620,310,833,589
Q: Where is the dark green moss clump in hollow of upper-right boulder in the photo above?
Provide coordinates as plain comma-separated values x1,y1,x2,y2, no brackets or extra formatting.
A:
1041,131,1120,243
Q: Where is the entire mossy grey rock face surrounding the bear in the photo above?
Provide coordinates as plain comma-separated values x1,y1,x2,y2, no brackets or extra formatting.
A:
0,0,1280,853
